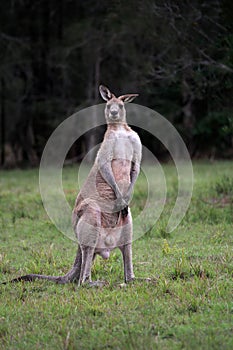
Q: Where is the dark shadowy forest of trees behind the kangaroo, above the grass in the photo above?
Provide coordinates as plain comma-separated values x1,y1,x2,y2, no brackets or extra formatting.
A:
0,0,233,165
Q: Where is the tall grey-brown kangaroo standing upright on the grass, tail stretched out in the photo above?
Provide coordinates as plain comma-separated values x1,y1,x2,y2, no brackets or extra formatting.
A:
4,85,142,286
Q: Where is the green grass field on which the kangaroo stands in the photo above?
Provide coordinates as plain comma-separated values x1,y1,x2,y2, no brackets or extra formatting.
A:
0,162,233,350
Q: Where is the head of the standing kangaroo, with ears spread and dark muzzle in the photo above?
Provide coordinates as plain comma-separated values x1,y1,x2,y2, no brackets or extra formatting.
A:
99,85,138,124
